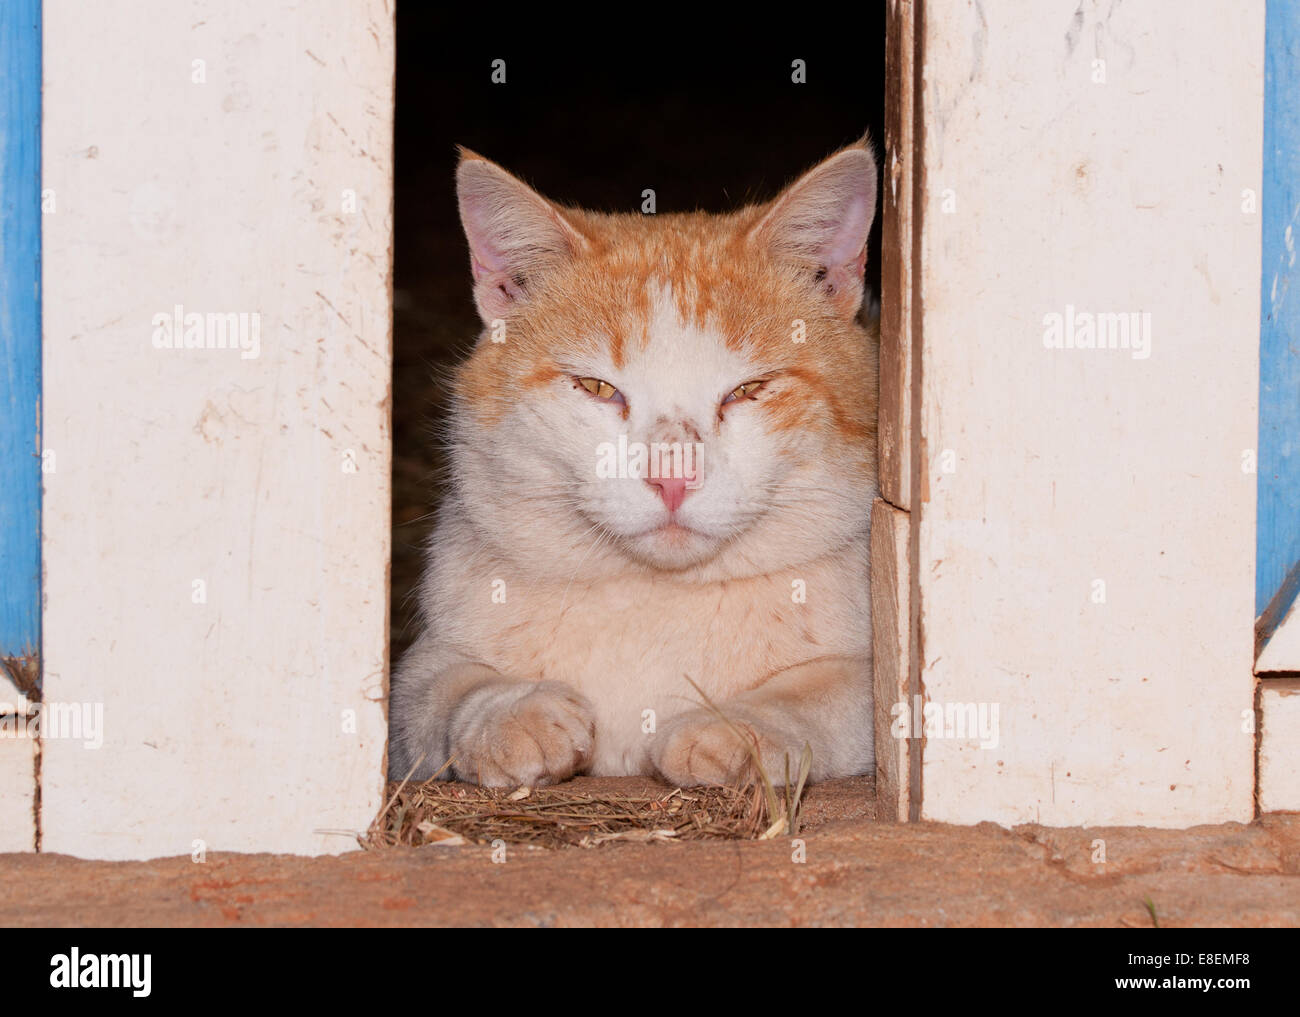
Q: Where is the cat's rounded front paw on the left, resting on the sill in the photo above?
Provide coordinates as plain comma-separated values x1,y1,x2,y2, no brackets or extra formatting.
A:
450,681,595,787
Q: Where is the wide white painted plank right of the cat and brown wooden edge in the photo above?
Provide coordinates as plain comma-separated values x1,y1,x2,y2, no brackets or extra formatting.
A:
919,0,1264,827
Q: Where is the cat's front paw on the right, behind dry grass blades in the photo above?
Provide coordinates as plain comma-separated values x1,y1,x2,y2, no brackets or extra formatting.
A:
651,709,800,787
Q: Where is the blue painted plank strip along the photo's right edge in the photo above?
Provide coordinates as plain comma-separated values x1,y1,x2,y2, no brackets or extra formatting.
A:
1255,0,1300,616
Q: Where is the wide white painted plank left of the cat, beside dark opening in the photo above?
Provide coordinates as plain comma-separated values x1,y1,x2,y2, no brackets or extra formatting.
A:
43,0,394,858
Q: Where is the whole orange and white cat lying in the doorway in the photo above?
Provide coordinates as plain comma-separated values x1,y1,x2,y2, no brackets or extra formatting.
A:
389,139,876,787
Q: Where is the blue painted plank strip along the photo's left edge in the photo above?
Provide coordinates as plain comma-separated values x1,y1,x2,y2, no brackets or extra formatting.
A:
0,0,40,657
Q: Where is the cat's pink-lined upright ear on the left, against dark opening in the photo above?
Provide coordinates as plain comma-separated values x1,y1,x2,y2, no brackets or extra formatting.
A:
456,148,585,325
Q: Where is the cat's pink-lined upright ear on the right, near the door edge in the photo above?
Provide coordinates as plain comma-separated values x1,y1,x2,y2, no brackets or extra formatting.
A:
749,139,876,317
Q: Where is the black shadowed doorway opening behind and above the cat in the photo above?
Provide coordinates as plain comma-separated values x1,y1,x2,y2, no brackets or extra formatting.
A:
390,5,887,847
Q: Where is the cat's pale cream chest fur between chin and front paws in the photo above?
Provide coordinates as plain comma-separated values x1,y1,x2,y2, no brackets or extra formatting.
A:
460,554,870,775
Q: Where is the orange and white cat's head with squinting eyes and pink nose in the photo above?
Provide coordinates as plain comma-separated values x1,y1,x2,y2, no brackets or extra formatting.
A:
441,143,876,580
